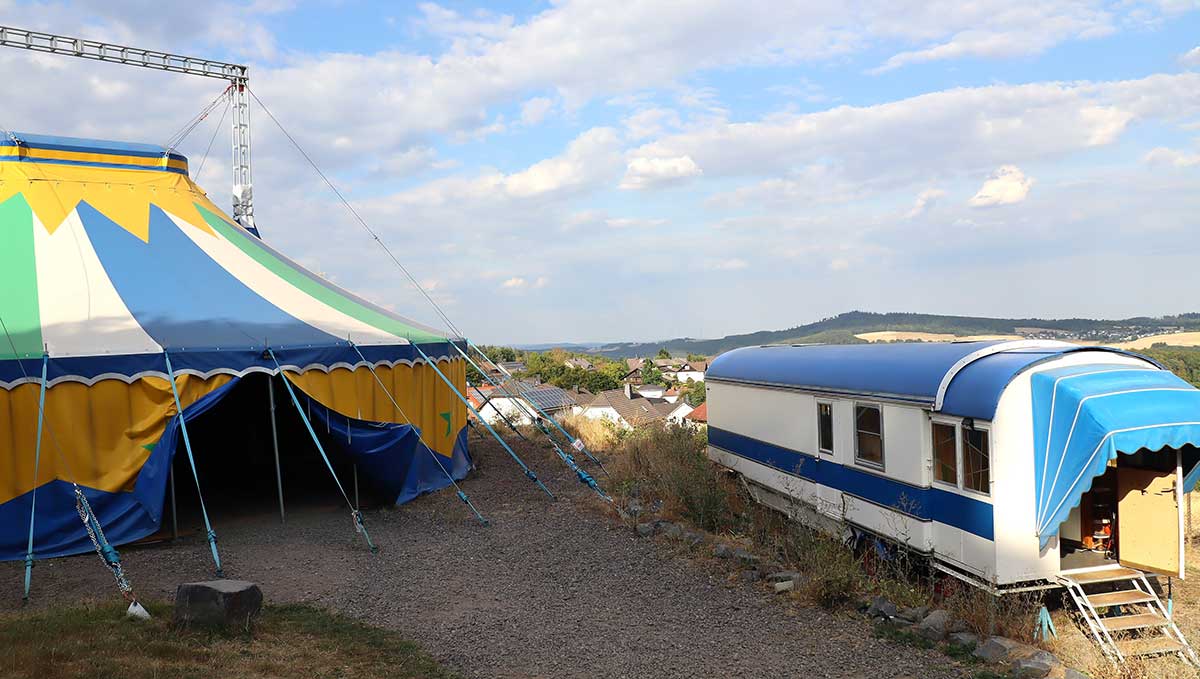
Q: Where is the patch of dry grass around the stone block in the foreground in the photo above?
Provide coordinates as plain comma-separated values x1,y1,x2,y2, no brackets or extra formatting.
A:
0,603,452,679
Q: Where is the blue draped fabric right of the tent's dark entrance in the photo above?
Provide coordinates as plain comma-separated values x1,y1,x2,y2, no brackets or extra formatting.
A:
296,391,470,505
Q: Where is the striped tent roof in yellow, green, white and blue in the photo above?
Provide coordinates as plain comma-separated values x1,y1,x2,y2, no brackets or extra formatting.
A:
0,133,449,386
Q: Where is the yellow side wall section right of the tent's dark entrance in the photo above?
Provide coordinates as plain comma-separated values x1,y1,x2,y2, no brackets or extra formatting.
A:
286,359,467,457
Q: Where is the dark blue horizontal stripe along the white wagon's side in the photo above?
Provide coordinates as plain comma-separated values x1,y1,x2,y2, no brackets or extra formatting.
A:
708,426,995,540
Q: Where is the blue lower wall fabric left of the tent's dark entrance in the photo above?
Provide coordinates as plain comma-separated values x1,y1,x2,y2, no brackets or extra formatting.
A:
0,378,239,561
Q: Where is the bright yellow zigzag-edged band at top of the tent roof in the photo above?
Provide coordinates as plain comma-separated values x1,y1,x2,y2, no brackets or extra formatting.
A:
0,162,235,241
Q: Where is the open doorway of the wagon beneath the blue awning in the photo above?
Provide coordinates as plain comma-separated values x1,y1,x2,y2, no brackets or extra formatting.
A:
1061,446,1200,577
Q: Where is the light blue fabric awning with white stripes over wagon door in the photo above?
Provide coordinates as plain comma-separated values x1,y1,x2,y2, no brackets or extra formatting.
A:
1031,363,1200,548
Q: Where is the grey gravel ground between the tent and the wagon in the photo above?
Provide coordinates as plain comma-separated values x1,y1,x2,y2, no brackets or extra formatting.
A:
0,437,966,678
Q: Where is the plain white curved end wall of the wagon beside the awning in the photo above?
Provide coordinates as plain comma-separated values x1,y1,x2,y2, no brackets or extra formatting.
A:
991,351,1156,584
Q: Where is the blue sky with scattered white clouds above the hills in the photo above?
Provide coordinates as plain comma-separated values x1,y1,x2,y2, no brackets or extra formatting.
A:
0,0,1200,343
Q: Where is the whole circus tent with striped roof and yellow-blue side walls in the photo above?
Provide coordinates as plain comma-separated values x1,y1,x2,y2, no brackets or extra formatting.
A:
0,133,470,560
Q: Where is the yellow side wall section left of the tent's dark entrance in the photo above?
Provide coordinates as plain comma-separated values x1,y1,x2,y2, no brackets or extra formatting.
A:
0,374,233,504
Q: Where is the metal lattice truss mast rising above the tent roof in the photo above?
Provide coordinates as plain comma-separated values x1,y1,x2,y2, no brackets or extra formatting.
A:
0,25,258,233
